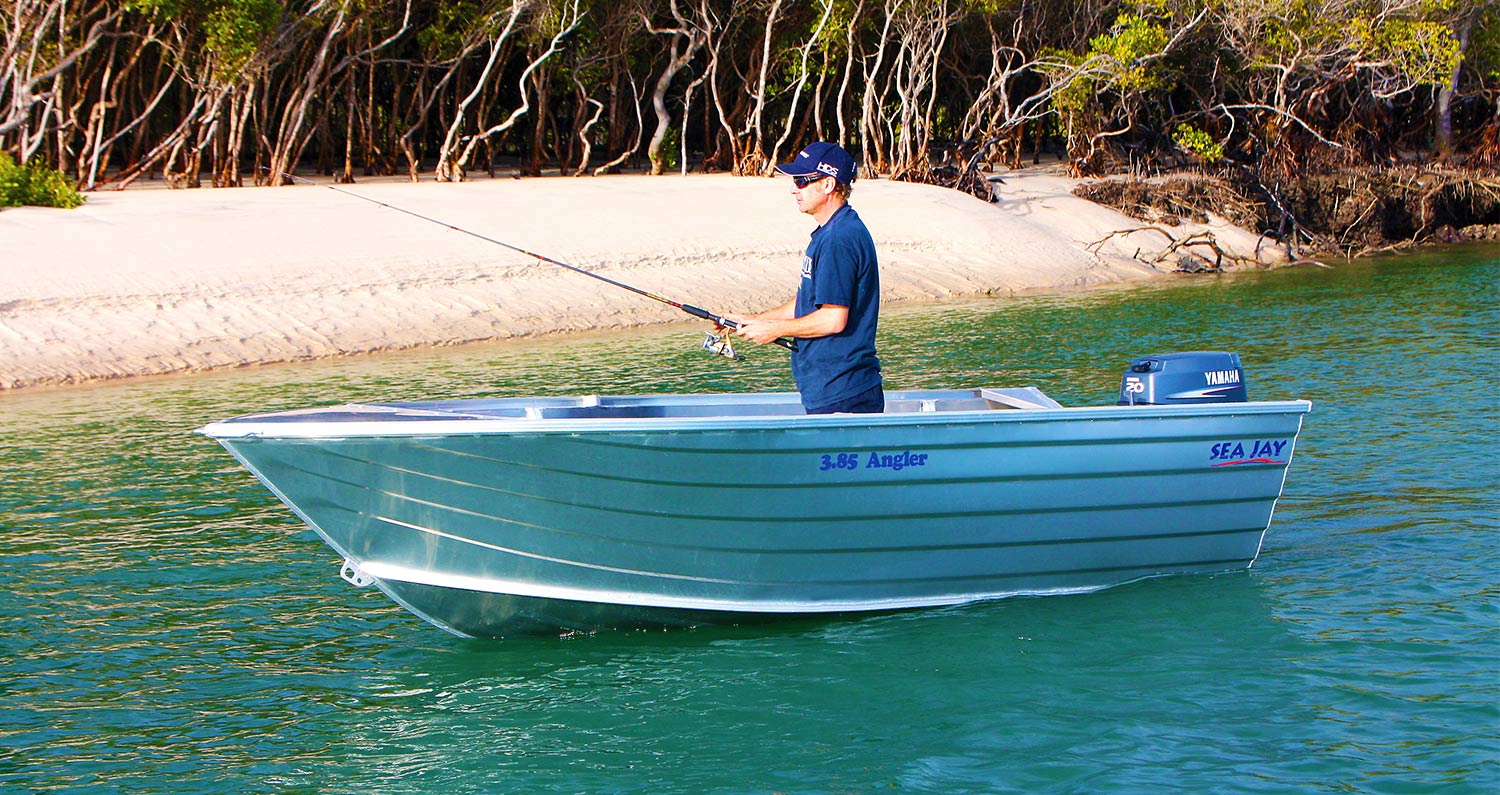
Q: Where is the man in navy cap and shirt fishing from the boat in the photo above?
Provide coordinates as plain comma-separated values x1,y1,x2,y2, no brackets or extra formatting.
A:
732,143,885,414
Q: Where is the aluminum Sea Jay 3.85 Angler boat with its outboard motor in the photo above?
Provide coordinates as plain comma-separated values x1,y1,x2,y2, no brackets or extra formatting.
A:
200,353,1311,638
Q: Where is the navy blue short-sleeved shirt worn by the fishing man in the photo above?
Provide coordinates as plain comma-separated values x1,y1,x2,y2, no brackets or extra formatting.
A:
792,204,881,408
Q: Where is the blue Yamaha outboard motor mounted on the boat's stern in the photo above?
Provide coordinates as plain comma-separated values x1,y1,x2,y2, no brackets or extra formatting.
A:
1119,351,1248,407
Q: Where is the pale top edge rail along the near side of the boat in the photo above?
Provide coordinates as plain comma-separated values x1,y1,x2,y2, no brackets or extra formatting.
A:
197,399,1313,441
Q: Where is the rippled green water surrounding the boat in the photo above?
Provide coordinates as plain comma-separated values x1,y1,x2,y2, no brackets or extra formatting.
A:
0,248,1500,794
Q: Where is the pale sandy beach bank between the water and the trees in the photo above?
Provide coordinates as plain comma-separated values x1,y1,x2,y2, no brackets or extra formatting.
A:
0,167,1278,390
